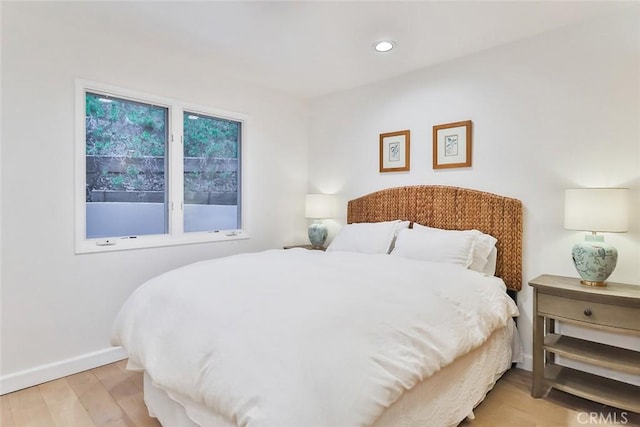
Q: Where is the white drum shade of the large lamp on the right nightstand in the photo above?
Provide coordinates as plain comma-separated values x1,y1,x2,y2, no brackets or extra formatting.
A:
564,188,629,233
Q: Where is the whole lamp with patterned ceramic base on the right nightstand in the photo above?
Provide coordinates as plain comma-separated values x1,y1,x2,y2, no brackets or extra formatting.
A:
564,188,629,286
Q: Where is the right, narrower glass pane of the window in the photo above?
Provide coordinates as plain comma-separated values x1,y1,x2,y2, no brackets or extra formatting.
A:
184,112,241,232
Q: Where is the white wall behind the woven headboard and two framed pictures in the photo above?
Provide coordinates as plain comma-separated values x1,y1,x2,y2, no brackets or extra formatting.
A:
309,8,640,367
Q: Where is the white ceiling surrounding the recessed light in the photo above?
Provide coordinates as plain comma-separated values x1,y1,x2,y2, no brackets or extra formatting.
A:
18,0,630,98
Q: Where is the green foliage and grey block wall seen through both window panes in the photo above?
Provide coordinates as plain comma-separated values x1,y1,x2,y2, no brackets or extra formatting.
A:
85,93,240,203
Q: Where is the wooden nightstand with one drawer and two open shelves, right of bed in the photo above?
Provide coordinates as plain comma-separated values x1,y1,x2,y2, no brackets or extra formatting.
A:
529,274,640,412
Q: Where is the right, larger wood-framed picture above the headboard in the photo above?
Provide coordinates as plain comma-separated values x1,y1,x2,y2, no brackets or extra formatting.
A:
433,120,471,169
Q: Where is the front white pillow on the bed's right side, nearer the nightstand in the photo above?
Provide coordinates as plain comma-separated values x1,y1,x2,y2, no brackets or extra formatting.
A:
391,228,475,268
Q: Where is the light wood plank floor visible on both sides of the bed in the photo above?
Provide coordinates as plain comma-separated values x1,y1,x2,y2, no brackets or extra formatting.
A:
0,361,640,427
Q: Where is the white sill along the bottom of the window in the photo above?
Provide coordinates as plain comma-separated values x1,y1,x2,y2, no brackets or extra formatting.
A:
75,230,250,254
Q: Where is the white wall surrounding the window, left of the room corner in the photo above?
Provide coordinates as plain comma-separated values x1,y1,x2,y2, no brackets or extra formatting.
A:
1,2,309,392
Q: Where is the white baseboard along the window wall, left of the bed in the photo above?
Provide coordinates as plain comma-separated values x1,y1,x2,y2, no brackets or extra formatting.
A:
0,347,127,394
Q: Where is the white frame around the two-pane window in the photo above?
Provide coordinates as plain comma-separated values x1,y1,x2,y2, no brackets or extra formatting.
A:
75,79,249,254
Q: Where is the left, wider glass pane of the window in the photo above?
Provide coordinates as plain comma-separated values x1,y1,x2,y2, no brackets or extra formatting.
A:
85,92,168,238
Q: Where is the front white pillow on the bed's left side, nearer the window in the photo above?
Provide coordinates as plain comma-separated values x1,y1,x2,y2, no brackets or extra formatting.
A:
327,220,409,254
